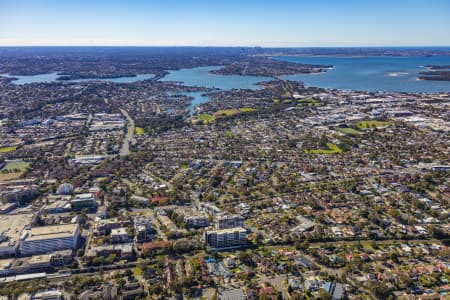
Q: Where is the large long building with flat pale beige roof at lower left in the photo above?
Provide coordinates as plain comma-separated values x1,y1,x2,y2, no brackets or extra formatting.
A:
19,224,80,255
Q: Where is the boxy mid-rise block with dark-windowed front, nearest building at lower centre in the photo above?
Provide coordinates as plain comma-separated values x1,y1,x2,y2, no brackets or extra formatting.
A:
205,227,247,249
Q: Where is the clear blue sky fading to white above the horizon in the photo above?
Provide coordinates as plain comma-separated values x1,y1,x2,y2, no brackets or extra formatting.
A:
0,0,450,47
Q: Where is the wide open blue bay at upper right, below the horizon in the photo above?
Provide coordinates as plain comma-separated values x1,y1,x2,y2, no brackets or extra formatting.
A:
274,56,450,93
